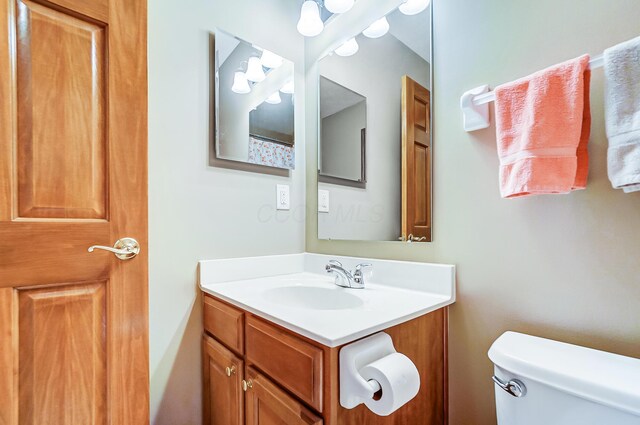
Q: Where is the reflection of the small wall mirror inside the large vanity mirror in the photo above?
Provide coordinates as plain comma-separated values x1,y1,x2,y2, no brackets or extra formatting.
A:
318,77,367,187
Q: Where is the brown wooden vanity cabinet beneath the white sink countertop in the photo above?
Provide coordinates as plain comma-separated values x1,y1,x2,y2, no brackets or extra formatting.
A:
203,294,447,425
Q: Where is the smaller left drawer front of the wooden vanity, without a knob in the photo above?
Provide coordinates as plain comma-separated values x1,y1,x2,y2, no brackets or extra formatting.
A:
204,295,244,354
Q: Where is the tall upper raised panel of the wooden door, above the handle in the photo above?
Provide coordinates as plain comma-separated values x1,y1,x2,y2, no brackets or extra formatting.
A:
16,0,107,219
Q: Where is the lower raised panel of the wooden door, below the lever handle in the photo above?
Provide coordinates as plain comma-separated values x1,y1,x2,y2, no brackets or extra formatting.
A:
17,282,107,425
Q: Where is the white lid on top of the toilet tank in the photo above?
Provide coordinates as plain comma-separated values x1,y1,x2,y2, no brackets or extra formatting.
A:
489,332,640,416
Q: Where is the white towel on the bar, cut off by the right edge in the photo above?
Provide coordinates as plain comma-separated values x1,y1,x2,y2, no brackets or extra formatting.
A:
604,37,640,192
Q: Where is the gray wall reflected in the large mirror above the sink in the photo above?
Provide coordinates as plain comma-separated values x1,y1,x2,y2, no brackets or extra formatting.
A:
316,33,431,241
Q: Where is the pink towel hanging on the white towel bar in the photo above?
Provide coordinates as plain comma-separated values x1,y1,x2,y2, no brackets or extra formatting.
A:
495,55,591,198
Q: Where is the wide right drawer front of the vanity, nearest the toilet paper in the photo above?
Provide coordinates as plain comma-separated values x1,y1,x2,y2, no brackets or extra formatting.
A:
246,316,322,412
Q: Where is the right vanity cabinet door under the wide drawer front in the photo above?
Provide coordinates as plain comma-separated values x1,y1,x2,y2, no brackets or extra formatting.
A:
245,368,322,425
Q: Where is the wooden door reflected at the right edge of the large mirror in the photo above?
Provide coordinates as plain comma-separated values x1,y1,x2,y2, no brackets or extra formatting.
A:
402,75,432,242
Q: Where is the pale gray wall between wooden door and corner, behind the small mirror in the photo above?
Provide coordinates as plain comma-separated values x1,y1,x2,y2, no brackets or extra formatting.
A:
149,0,305,425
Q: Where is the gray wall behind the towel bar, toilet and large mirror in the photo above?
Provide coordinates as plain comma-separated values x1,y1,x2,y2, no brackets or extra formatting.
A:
306,0,640,425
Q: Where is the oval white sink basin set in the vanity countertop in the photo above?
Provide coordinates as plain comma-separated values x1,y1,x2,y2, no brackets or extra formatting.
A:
263,285,364,310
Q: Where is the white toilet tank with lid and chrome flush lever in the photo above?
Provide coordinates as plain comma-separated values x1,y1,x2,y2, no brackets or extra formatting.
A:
489,332,640,425
